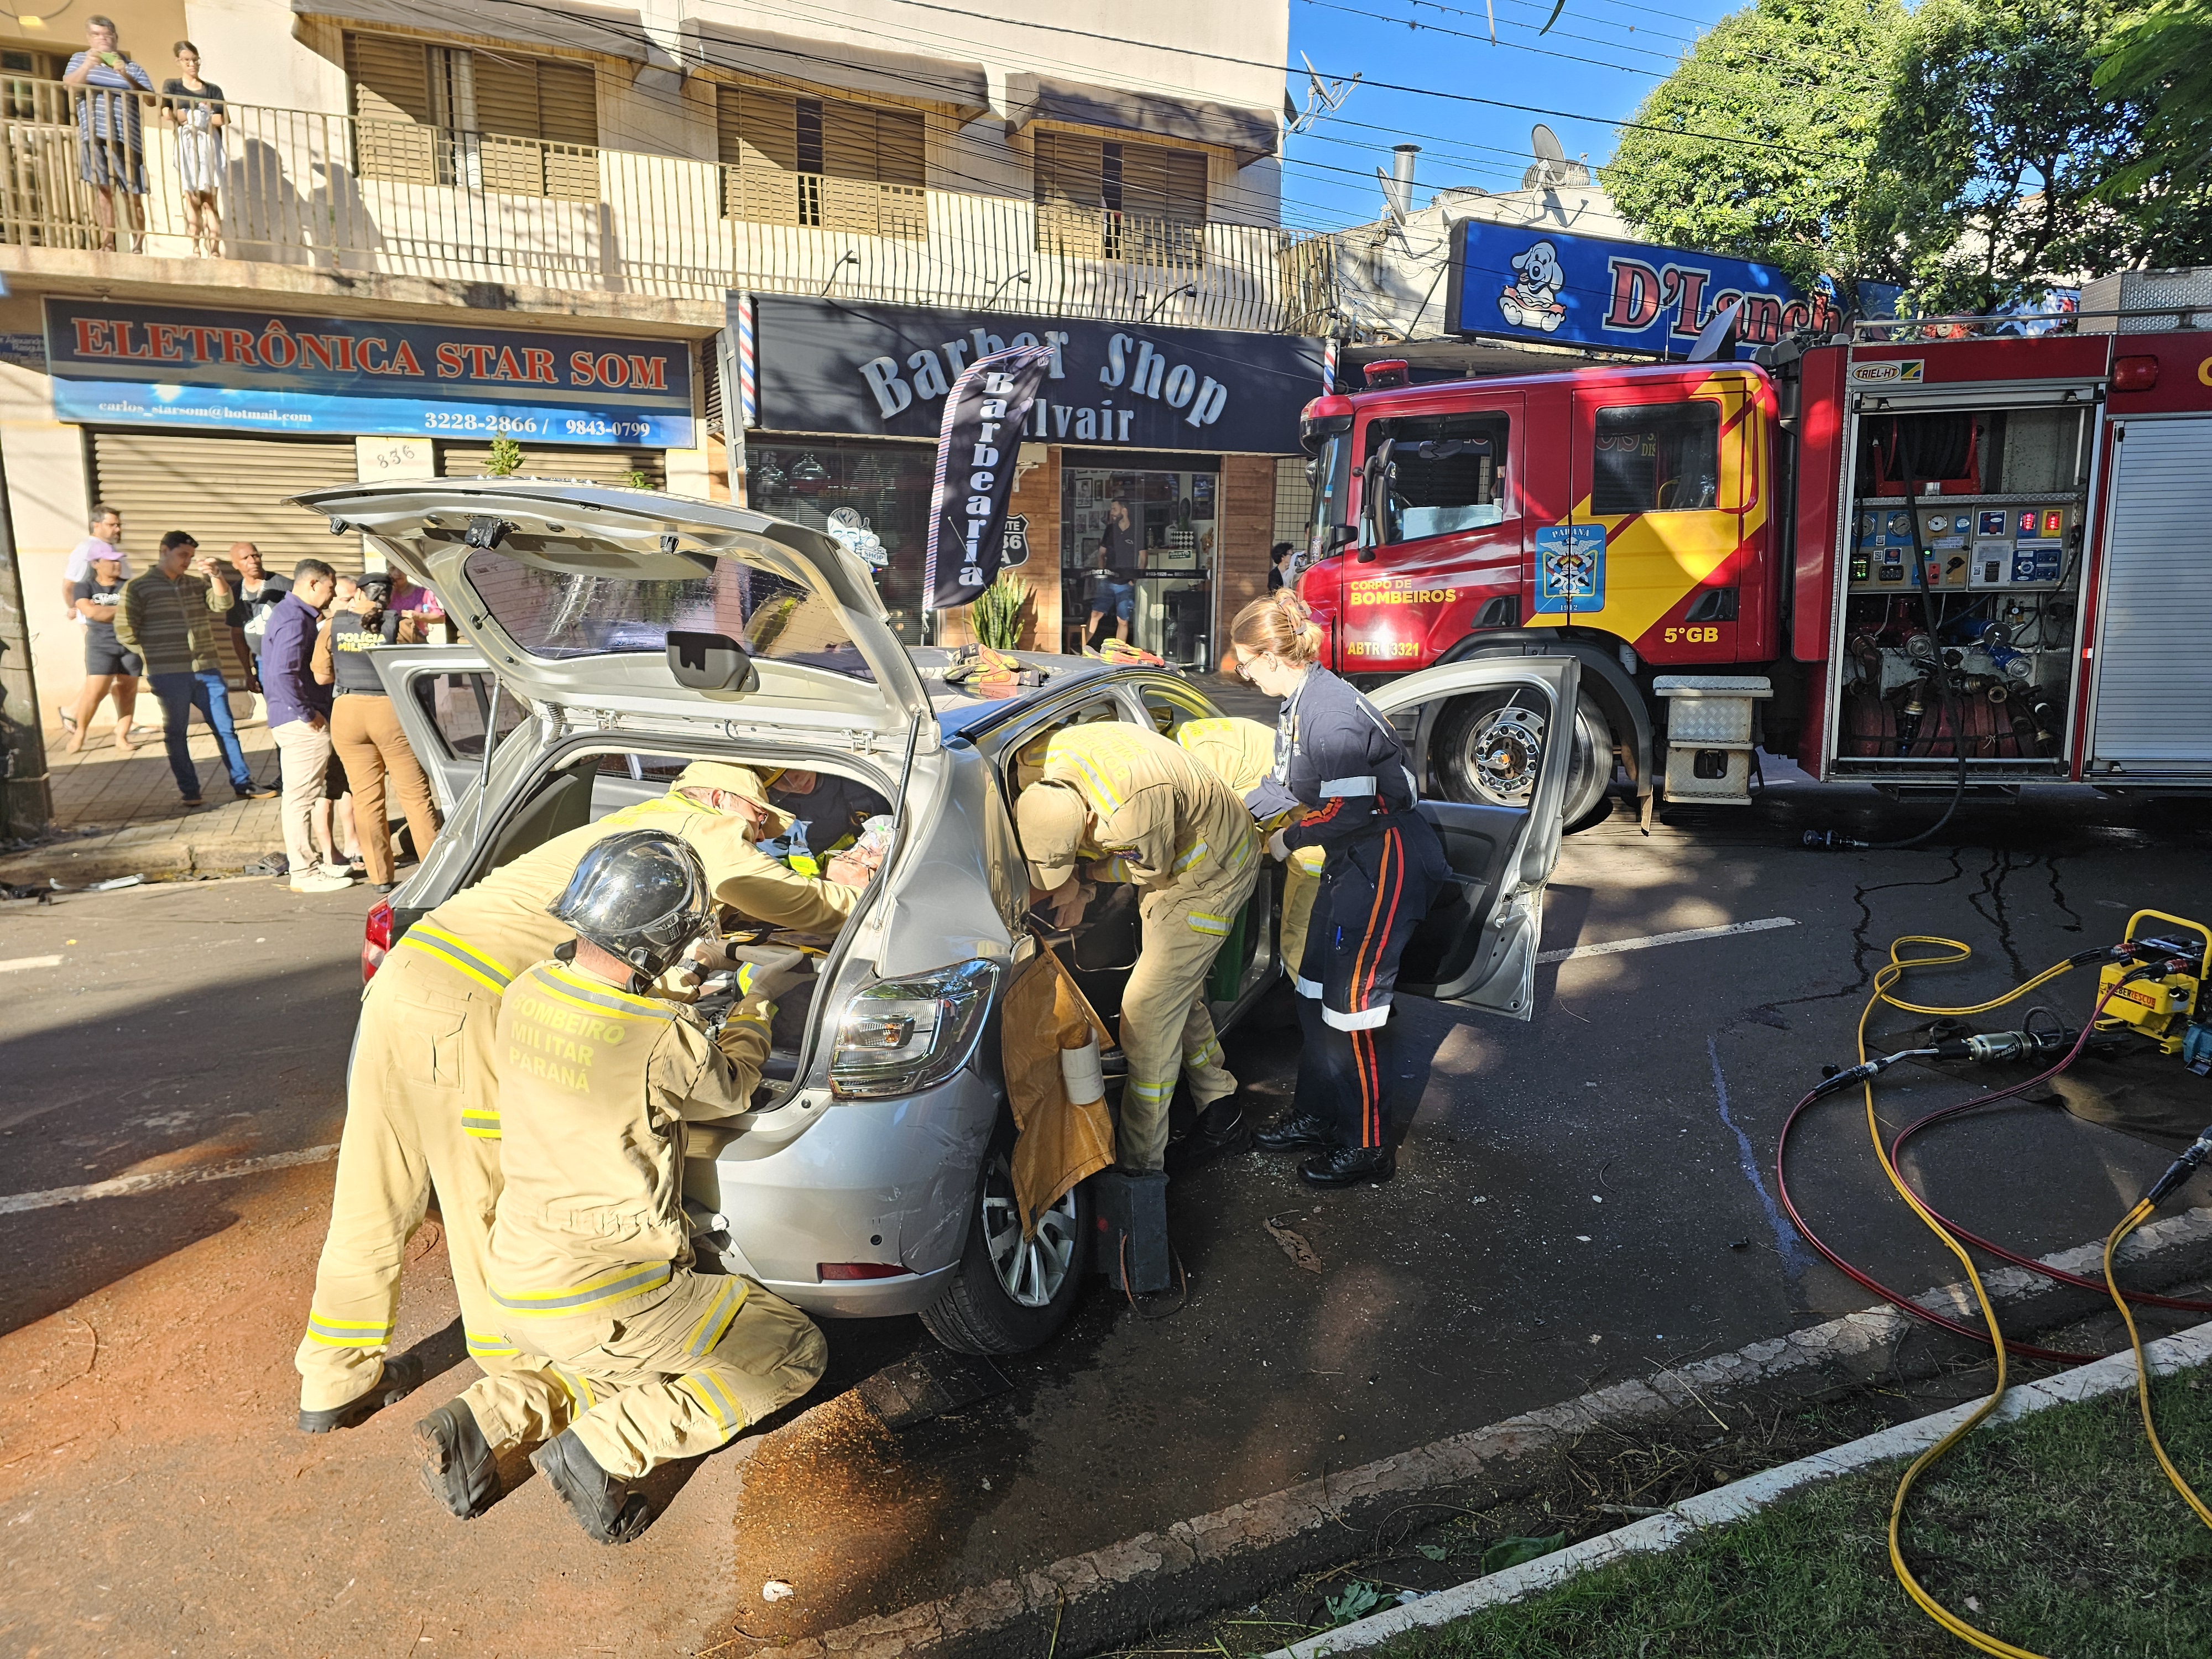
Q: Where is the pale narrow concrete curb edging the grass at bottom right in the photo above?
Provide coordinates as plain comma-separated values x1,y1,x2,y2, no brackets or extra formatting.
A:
1267,1325,2212,1659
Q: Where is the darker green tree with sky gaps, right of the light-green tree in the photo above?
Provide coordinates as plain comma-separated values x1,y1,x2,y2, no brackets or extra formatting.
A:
1860,0,2157,312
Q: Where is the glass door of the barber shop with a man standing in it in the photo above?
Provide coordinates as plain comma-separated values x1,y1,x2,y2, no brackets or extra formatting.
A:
1060,456,1221,668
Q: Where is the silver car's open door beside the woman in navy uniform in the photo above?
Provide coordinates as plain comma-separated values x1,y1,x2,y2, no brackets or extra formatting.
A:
1367,657,1582,1020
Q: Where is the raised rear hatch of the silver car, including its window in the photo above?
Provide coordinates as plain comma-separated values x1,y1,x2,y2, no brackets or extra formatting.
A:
296,478,936,752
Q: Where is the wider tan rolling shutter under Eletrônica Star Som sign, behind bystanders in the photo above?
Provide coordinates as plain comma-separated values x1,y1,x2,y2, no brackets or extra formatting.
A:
93,431,361,575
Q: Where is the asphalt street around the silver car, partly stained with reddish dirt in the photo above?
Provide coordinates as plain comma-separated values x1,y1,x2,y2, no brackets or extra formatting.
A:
0,790,2212,1655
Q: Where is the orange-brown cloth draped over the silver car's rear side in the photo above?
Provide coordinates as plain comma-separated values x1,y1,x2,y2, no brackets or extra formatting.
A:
1000,951,1113,1239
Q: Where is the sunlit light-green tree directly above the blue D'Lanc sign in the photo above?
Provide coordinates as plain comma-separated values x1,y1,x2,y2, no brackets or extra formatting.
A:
1604,0,1905,281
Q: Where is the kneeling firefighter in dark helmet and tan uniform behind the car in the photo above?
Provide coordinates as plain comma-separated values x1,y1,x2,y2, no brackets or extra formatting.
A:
416,830,827,1544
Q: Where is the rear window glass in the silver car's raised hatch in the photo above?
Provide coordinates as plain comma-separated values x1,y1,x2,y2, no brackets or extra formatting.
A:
462,551,876,681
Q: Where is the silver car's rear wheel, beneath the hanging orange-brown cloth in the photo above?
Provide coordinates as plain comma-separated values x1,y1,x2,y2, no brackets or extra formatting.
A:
922,1126,1093,1354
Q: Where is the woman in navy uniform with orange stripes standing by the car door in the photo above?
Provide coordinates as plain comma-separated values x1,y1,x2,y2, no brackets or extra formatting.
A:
1230,588,1447,1186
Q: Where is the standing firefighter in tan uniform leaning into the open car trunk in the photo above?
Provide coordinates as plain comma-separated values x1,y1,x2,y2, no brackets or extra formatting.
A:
294,761,865,1433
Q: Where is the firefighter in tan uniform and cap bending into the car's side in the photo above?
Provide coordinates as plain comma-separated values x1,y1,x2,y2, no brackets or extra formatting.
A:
1015,721,1259,1172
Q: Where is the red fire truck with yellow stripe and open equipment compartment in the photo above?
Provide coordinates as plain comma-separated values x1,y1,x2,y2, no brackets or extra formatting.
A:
1298,314,2212,827
